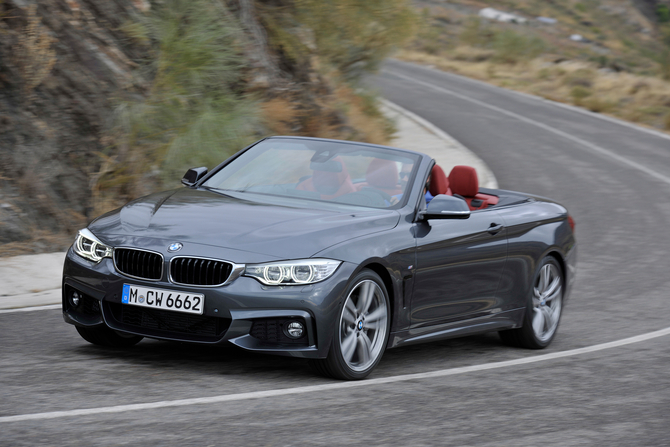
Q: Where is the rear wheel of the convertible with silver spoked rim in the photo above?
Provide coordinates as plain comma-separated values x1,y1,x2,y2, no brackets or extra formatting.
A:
498,256,564,349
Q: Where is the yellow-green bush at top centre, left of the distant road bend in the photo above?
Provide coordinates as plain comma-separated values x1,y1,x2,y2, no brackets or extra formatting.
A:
256,0,417,80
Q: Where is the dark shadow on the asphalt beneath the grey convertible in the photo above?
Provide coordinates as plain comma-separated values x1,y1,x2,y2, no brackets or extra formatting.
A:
74,333,516,383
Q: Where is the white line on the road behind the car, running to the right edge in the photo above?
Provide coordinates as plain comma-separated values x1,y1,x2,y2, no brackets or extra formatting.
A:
393,73,670,185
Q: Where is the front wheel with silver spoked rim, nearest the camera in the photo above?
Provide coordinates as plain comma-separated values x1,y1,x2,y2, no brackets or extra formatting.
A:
310,270,391,380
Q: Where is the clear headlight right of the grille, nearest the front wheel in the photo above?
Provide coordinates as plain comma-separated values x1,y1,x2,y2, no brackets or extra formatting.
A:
244,259,342,286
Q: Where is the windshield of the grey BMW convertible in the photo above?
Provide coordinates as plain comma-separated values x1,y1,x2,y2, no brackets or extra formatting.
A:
202,138,419,208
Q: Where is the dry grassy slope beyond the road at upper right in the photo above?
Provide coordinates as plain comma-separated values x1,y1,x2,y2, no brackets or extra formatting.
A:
398,0,670,131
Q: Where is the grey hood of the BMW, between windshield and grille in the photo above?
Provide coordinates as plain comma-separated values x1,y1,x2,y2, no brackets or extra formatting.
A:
88,189,400,262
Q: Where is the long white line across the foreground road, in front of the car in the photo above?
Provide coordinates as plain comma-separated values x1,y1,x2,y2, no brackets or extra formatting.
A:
0,327,670,423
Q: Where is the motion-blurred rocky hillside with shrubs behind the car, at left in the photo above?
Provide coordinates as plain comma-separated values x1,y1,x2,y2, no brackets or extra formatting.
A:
0,0,415,256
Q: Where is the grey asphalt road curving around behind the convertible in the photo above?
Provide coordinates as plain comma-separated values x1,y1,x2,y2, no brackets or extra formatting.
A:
0,61,670,446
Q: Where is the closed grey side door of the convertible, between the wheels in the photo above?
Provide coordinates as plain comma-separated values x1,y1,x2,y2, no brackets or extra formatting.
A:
411,210,507,328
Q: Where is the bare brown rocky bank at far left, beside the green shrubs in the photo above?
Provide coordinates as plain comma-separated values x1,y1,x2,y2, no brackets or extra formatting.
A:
0,0,148,250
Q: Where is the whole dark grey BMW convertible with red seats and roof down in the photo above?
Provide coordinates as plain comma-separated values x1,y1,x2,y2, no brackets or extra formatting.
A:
63,137,576,379
